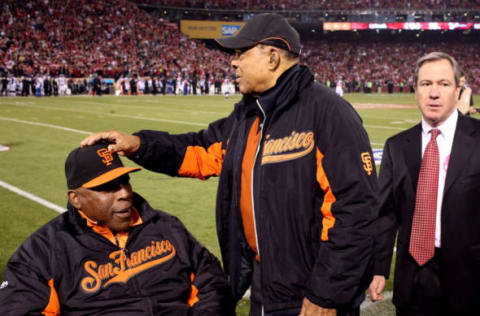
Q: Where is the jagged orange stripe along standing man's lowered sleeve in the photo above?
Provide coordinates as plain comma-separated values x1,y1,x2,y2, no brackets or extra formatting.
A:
316,148,336,241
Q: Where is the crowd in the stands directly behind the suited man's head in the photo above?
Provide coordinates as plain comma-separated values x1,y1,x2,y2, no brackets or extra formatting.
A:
302,42,480,93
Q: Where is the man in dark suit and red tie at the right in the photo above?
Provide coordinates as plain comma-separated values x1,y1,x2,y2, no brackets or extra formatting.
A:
368,52,480,316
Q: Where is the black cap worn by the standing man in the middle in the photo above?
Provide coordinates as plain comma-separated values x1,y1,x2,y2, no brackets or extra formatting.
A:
215,13,301,55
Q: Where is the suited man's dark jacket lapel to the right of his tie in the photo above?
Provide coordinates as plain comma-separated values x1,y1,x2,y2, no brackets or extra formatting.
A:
443,115,475,196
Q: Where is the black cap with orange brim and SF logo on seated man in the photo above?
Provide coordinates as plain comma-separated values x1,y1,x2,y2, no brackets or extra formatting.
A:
65,144,142,190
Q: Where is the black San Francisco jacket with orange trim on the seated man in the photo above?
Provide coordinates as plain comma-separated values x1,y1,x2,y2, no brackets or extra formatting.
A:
0,194,231,316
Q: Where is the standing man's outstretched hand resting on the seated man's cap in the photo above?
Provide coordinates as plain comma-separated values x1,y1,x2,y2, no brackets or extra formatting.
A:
80,131,140,156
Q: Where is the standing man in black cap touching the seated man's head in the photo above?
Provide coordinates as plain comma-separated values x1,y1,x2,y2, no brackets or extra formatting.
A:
82,14,377,316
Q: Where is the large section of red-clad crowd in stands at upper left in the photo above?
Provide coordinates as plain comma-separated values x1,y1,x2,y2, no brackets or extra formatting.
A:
0,0,229,82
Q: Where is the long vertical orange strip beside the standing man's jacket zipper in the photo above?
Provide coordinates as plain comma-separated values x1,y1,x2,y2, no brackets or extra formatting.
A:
240,117,261,260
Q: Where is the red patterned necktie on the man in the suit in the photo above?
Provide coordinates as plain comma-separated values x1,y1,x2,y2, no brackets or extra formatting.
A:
409,129,440,266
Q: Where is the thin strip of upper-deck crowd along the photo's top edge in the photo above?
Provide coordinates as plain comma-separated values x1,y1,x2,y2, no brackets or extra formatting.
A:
135,0,480,10
